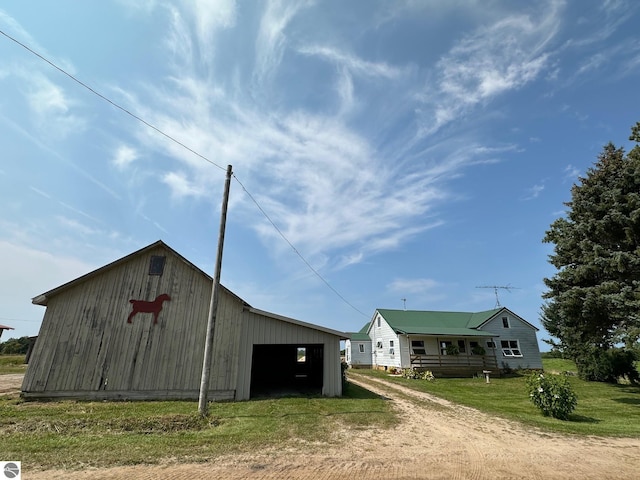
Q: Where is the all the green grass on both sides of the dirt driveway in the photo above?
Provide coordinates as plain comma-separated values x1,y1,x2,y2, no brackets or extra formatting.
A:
0,356,640,469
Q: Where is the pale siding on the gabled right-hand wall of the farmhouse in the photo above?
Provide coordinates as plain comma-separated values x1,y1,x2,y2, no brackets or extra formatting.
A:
480,311,542,370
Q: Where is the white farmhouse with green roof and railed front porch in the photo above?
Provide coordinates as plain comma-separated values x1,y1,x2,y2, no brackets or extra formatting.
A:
346,307,542,376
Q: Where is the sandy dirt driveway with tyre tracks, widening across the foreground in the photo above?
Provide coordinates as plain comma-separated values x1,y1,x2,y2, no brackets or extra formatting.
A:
0,373,640,480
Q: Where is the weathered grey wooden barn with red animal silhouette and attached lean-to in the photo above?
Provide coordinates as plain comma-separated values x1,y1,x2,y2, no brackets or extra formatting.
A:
22,241,345,400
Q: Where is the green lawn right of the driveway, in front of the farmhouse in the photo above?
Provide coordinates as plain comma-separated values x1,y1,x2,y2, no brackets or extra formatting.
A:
357,359,640,437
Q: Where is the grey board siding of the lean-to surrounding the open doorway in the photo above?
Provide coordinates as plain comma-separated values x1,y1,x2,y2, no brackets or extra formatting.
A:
236,310,342,400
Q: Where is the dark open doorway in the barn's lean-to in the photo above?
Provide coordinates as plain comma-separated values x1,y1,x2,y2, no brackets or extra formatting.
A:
250,344,324,398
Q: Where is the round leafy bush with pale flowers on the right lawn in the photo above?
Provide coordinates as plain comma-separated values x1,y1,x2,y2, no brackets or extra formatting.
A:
526,373,578,420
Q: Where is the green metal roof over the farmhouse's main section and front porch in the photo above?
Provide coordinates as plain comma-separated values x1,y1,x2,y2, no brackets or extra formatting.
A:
378,308,502,337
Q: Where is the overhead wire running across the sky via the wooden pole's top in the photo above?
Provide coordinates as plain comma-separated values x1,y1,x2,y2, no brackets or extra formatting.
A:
0,26,368,317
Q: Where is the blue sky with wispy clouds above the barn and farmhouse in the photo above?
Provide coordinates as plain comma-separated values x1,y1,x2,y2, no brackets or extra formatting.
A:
0,0,640,350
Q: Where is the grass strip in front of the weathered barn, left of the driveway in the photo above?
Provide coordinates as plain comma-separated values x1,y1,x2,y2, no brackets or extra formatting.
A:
0,385,397,469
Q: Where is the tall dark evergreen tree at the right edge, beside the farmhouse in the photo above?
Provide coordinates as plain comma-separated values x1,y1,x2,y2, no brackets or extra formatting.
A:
542,122,640,381
